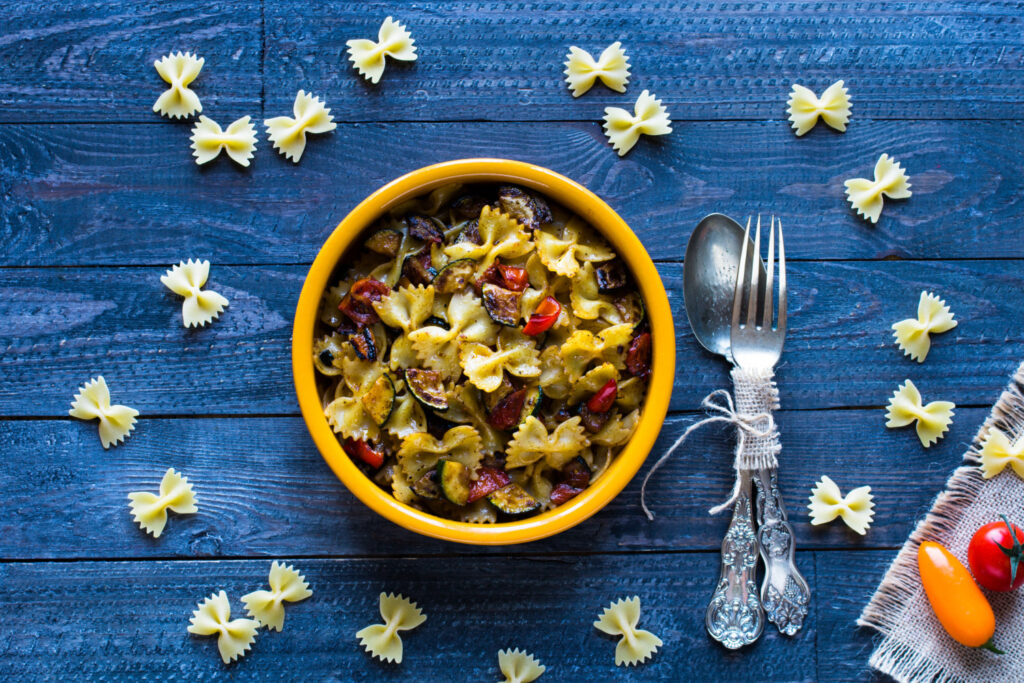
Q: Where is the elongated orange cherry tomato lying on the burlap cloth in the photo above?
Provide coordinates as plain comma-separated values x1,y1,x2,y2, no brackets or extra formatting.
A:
918,541,1001,653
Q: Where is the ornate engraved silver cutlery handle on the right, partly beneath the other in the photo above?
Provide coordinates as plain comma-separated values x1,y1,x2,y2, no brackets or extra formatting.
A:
755,468,811,636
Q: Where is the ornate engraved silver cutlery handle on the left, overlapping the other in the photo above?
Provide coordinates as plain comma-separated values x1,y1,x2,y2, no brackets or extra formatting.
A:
705,471,765,650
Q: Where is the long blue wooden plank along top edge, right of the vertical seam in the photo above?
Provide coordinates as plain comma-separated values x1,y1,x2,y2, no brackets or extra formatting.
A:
266,0,1024,121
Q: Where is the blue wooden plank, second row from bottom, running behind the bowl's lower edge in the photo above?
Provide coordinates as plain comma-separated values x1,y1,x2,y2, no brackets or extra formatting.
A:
0,409,987,559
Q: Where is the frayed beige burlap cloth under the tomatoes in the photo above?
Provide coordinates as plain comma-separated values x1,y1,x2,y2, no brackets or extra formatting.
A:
857,364,1024,683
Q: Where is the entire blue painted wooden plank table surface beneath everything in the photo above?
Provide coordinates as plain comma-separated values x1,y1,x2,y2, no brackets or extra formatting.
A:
0,0,1024,681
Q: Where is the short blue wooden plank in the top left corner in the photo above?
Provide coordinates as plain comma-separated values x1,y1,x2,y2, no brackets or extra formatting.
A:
0,0,262,122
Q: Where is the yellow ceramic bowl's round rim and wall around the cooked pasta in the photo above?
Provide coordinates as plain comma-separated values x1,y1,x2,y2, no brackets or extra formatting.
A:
292,159,676,545
